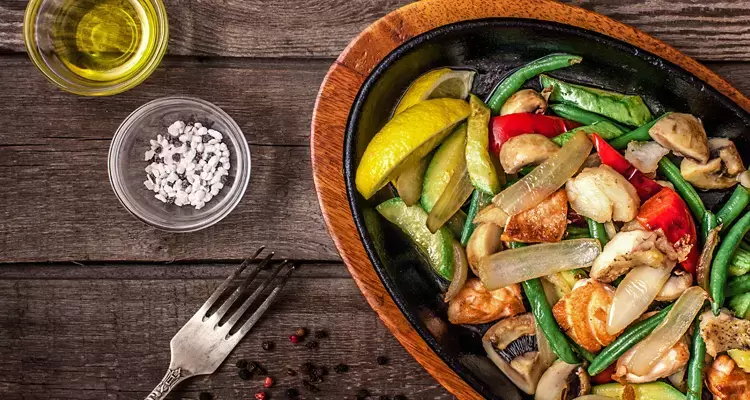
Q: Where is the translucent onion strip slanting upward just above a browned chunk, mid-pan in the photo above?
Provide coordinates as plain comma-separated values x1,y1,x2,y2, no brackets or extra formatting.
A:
492,132,593,215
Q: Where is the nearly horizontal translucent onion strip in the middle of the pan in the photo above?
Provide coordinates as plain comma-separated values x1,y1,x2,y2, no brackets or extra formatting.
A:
477,239,602,290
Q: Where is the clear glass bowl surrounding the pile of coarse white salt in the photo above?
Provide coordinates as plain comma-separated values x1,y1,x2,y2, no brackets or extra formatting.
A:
108,96,250,232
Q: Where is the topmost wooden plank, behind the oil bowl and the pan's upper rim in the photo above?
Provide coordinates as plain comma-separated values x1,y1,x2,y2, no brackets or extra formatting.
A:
0,0,750,60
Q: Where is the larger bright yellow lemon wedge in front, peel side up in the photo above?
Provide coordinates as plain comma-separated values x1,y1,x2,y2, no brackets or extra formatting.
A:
355,98,471,199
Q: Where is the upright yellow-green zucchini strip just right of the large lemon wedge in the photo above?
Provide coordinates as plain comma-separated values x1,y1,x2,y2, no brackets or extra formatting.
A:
466,94,500,195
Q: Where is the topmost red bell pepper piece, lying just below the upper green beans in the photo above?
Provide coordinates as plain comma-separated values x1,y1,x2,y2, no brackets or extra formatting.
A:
490,113,581,154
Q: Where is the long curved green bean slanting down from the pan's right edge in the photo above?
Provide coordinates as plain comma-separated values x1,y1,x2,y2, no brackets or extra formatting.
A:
709,209,750,315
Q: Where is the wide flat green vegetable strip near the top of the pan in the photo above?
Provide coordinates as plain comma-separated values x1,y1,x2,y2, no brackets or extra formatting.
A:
539,75,654,126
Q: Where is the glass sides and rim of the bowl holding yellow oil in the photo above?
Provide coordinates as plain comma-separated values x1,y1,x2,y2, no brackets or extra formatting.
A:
23,0,169,96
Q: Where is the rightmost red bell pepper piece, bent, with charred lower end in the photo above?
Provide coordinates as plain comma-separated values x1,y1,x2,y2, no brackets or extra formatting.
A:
635,187,700,274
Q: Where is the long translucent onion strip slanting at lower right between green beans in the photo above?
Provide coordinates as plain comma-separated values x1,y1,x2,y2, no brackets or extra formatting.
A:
626,286,708,375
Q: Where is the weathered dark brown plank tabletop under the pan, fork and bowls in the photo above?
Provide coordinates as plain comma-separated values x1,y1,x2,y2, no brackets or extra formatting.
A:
0,0,750,400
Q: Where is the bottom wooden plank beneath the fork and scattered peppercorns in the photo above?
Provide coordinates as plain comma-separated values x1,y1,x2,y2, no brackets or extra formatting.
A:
0,264,452,400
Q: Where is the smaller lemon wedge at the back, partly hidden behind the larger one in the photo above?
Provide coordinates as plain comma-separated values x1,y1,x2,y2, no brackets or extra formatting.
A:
393,68,476,115
